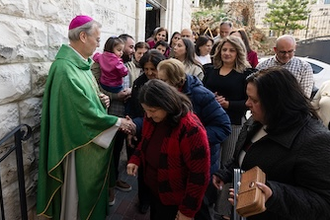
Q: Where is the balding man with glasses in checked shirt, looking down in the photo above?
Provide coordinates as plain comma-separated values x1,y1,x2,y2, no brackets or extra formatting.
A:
256,35,314,98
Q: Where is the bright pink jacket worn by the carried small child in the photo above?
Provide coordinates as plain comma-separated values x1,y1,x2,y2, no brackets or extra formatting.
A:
93,52,128,87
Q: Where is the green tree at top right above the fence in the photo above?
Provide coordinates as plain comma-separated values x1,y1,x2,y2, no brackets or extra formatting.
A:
264,0,311,35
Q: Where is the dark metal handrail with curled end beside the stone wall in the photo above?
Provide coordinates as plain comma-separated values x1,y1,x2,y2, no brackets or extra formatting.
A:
0,124,32,220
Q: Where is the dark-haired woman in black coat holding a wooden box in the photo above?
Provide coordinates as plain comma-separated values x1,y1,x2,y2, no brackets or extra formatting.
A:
213,68,330,220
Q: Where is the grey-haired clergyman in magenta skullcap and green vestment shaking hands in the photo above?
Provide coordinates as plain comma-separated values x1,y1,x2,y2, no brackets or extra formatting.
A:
37,15,134,220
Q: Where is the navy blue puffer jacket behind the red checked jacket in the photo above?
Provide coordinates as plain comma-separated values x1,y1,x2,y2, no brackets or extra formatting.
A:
181,74,231,174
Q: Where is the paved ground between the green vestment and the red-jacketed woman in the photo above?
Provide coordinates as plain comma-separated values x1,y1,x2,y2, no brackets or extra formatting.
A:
107,149,149,220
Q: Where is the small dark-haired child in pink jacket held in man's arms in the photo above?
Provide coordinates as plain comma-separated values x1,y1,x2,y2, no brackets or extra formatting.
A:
93,37,128,93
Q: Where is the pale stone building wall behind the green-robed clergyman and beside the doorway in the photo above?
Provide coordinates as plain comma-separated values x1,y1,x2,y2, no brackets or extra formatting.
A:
0,0,191,220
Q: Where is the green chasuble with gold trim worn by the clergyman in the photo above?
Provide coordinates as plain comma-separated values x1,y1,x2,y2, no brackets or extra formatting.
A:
37,45,118,220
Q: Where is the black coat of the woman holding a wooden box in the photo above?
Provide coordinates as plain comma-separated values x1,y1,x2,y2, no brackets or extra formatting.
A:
216,117,330,220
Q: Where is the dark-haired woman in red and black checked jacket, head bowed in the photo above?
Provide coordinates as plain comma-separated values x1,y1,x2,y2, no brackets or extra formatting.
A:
127,79,210,220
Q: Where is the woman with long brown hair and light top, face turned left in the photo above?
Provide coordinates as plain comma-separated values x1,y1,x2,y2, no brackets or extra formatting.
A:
174,38,204,80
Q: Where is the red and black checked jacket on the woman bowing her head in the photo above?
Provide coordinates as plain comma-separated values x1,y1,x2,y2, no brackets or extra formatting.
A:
129,113,210,217
